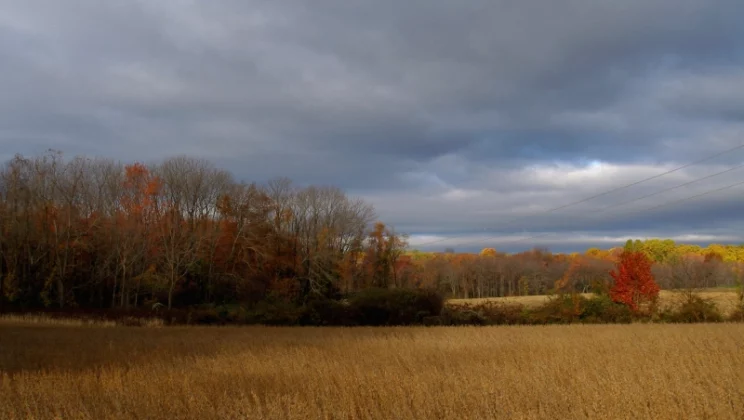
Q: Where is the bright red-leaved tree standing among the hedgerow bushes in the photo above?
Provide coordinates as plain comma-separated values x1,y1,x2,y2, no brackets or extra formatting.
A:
610,250,659,311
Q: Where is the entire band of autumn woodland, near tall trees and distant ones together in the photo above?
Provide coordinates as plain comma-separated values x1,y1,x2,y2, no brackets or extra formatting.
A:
0,151,744,309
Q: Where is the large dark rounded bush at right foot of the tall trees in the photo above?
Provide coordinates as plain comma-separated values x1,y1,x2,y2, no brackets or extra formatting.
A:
349,288,444,326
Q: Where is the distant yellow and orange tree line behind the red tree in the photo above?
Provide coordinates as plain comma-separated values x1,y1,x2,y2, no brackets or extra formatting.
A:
406,239,744,299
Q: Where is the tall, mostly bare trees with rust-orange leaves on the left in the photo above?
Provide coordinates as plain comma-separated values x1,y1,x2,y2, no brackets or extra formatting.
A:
0,151,406,308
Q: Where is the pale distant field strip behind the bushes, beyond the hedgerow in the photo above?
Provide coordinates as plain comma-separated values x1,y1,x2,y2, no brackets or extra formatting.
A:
447,289,738,316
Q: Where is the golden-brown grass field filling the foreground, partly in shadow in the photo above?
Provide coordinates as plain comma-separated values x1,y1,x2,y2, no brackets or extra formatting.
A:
0,324,744,420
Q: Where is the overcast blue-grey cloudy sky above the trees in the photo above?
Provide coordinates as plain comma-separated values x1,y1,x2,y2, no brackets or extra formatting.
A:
0,0,744,252
